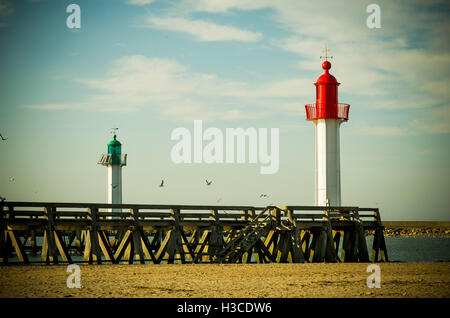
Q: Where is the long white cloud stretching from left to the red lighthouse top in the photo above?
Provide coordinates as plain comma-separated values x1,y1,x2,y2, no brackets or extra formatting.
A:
26,55,312,120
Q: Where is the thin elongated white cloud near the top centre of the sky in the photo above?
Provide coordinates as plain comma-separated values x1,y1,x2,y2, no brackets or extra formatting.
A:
148,16,262,42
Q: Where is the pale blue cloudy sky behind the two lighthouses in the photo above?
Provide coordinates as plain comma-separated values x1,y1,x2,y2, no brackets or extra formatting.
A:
0,0,450,221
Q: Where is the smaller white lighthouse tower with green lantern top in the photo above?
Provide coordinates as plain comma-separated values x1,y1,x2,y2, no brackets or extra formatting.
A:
97,133,127,212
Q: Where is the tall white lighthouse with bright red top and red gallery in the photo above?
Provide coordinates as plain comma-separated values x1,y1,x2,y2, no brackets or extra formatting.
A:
305,56,350,206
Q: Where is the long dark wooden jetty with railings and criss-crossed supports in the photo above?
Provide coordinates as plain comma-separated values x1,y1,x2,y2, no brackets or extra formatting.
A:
0,201,388,264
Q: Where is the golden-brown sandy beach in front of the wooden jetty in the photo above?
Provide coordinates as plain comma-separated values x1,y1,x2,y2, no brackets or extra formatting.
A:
0,262,450,298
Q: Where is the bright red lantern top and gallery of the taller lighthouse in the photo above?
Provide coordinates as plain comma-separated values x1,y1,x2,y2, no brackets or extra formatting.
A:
305,61,350,120
